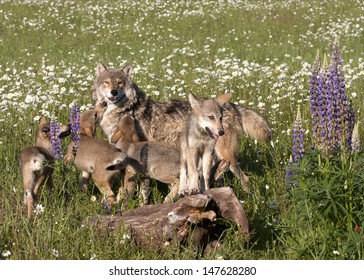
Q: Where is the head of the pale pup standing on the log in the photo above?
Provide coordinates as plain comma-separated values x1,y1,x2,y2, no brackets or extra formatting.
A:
188,92,232,140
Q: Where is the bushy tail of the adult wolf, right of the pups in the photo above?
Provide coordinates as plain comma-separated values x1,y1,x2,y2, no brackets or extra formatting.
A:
237,106,272,142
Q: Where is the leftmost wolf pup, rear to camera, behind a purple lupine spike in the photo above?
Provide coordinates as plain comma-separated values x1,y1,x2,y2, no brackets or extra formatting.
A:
19,117,71,218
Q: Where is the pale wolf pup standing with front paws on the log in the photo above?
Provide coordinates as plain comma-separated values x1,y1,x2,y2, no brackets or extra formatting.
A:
179,93,232,195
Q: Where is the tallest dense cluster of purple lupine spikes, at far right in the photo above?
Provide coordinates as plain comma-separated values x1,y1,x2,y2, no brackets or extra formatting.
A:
310,39,355,155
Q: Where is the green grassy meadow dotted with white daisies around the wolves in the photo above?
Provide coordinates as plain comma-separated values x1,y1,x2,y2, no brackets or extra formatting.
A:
0,0,364,260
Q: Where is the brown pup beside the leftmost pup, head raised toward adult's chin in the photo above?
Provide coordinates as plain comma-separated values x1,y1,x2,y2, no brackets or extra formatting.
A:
64,109,127,207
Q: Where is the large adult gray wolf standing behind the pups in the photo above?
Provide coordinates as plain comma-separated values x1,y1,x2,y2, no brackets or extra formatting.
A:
92,63,272,195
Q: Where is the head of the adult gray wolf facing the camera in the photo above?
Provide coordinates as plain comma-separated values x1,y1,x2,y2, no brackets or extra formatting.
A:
92,63,136,107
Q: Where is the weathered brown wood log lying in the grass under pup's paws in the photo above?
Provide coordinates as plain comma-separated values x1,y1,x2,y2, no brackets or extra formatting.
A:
82,187,249,248
